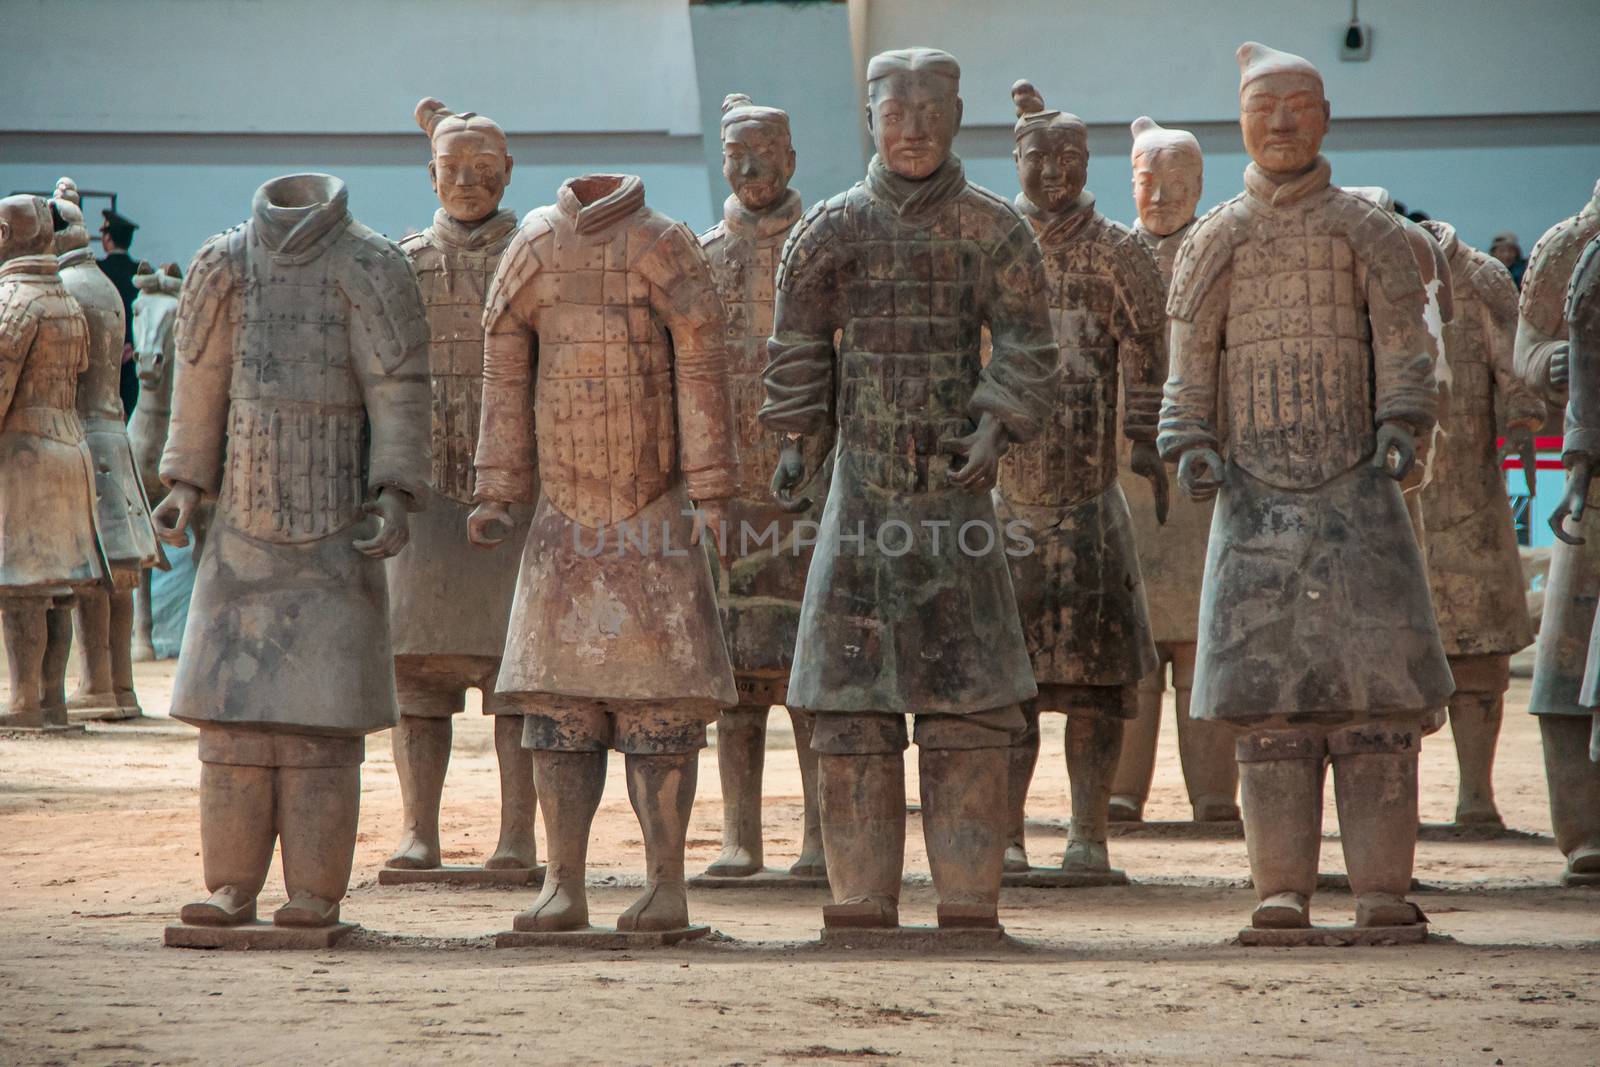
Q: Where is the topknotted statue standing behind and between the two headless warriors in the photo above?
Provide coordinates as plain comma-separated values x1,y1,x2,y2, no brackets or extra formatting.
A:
386,98,538,870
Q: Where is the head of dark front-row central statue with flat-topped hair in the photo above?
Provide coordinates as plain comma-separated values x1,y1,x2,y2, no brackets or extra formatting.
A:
867,48,962,179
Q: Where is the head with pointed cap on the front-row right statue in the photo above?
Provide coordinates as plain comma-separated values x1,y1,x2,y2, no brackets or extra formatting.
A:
1238,40,1328,174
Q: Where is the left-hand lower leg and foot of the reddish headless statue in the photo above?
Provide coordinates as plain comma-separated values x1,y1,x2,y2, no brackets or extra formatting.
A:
517,749,606,929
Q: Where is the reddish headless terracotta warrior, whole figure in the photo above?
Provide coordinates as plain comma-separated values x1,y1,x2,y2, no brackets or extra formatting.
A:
469,174,736,931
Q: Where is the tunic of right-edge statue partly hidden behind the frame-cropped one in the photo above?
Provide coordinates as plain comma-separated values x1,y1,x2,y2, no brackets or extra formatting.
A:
1515,182,1600,715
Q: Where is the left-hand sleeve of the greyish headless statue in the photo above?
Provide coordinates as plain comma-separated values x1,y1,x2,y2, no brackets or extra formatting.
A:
162,229,243,498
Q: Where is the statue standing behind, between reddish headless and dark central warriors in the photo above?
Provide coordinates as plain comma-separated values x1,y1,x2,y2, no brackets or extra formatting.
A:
701,93,827,878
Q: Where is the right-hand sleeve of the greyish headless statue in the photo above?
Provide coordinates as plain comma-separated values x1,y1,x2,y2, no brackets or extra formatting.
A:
349,235,434,510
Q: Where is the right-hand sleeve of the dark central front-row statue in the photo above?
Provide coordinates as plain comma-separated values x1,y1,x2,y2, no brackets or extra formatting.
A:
966,217,1061,442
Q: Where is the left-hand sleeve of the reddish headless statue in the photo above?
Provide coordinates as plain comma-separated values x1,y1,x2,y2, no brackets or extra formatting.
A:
472,219,549,504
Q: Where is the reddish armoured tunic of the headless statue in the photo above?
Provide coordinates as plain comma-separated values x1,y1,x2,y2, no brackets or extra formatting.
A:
475,174,736,718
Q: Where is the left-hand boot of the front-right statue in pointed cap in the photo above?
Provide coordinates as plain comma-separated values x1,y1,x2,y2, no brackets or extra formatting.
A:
1235,729,1326,929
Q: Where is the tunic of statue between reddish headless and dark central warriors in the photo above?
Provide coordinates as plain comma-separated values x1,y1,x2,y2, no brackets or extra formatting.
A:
699,189,827,707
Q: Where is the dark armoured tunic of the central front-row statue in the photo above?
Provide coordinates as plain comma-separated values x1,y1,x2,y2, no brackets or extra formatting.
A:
762,157,1059,715
